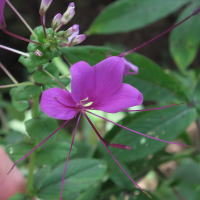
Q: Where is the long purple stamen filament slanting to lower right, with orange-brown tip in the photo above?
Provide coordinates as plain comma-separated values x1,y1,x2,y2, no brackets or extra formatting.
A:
84,114,151,198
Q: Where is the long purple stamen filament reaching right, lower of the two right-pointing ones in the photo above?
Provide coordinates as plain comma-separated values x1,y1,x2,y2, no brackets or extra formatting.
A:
86,110,191,147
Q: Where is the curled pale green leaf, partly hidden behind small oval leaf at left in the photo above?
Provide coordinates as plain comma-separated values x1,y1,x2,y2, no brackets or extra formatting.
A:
10,86,30,112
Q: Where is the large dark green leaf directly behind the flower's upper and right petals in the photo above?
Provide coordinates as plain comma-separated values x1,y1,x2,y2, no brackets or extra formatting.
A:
63,46,189,101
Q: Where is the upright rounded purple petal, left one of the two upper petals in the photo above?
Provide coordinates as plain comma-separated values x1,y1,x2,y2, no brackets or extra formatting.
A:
70,61,95,103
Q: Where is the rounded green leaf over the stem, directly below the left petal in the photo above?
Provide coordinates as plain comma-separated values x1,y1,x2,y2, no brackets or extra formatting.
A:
25,116,58,143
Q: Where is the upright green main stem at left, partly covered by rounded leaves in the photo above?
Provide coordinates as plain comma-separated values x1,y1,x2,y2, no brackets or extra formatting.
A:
27,97,39,196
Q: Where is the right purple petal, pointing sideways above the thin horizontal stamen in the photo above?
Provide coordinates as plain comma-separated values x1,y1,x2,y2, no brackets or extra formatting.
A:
91,83,143,113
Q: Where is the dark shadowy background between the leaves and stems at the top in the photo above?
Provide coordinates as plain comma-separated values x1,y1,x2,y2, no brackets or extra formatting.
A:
0,0,200,85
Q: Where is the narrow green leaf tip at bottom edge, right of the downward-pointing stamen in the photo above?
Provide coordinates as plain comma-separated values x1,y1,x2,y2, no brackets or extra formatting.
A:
76,184,101,200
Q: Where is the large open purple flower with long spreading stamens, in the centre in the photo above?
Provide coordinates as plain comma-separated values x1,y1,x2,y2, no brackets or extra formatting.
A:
11,56,190,199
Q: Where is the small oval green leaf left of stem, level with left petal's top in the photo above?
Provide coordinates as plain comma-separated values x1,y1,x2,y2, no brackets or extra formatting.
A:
15,85,42,101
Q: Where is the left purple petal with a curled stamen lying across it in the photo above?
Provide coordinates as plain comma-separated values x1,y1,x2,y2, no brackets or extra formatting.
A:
40,88,77,120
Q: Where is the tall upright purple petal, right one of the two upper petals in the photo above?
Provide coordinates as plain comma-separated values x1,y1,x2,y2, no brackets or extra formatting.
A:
89,56,124,104
